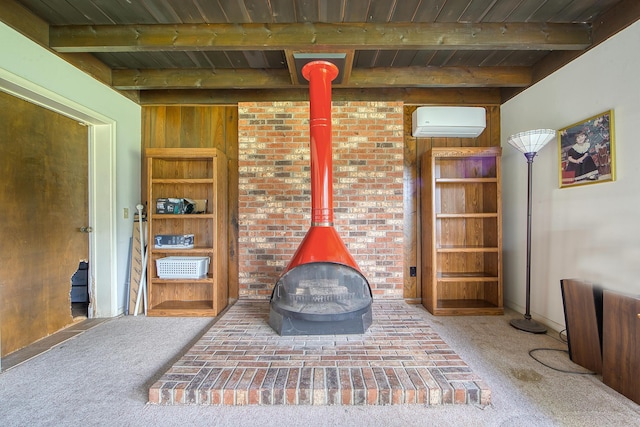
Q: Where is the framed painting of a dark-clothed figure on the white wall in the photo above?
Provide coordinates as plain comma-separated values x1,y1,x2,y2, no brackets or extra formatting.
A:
558,110,615,188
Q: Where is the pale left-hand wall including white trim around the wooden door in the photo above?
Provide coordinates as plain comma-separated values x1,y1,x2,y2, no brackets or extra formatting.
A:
0,23,141,317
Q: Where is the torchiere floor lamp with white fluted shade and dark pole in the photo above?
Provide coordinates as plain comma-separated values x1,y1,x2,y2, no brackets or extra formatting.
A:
507,129,556,334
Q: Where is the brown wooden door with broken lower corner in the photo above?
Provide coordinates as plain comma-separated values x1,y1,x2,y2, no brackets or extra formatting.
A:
0,93,89,355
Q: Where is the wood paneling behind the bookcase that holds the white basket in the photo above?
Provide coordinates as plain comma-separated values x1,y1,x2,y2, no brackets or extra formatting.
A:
141,105,238,299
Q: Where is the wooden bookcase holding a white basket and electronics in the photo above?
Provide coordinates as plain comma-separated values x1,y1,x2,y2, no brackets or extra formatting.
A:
145,148,228,316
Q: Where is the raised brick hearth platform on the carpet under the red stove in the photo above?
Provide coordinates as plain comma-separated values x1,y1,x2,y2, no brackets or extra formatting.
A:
149,300,491,405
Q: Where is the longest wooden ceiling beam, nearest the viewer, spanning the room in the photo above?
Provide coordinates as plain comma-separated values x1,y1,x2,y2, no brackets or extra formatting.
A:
49,23,591,52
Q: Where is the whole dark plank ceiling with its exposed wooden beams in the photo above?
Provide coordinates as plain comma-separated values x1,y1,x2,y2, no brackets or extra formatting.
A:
0,0,640,104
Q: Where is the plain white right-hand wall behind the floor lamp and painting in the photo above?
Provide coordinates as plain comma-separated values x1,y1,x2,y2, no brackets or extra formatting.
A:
501,22,640,330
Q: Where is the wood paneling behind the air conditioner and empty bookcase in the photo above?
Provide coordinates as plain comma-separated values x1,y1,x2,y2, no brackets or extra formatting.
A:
404,105,500,303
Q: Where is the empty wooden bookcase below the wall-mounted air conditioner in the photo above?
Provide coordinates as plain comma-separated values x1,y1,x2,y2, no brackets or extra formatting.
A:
420,147,504,315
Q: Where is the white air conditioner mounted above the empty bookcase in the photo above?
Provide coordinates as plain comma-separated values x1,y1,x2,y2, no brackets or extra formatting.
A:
411,107,487,138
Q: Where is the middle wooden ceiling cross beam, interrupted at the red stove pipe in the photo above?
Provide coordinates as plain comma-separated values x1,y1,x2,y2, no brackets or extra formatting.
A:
112,67,531,90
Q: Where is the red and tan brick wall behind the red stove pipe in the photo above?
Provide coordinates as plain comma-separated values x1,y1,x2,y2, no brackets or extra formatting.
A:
238,102,403,299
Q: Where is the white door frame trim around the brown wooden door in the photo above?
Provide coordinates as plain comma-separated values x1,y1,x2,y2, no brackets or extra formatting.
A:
0,72,118,317
